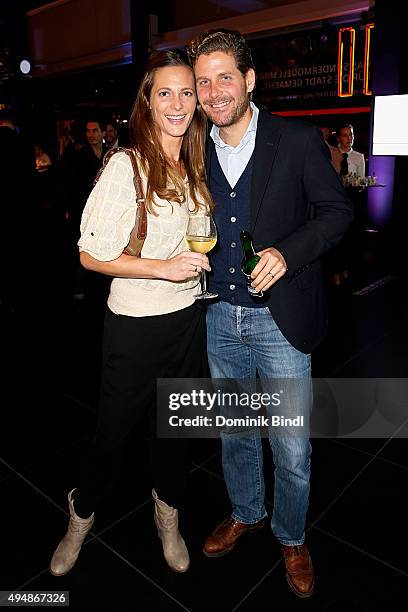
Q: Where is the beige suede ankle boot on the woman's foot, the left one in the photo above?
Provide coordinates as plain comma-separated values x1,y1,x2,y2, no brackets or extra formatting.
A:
50,489,94,576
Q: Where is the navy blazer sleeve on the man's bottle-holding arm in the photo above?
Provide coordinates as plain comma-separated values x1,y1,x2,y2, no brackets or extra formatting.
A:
274,128,353,275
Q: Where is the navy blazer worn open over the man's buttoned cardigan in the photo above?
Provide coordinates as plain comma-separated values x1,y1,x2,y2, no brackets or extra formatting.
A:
206,109,353,353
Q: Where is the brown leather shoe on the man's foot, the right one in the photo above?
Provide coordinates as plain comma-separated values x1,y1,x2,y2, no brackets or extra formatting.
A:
282,544,315,598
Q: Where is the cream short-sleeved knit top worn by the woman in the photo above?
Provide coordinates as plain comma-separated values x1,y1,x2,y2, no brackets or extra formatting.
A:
78,153,198,317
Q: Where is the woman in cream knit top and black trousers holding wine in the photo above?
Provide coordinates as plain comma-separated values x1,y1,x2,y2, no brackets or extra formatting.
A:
51,51,212,576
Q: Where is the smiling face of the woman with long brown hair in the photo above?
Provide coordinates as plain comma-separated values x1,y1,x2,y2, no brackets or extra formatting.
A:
150,66,197,151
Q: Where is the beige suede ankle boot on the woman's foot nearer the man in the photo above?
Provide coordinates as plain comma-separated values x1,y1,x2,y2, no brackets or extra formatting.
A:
152,489,190,572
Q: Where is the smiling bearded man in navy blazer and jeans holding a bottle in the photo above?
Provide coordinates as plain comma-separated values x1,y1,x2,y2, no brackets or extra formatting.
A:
189,30,352,597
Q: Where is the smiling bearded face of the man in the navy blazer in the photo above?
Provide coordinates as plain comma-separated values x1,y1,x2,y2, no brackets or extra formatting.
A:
194,51,255,127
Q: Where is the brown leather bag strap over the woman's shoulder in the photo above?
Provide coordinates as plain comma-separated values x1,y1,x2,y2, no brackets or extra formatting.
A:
94,147,147,257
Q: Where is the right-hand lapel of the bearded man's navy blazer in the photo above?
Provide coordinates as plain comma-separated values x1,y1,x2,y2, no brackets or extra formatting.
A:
251,109,281,232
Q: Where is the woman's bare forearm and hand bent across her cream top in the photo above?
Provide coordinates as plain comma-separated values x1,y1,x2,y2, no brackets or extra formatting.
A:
80,251,211,282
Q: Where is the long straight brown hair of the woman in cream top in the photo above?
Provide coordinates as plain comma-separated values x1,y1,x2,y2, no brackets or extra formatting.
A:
129,50,213,214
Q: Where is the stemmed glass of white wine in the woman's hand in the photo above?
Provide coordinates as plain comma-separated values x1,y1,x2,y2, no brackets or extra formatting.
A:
186,212,218,300
